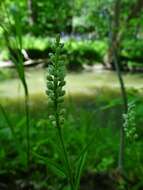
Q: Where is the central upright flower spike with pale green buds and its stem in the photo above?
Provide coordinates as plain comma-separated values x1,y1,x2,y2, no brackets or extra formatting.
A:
46,35,74,190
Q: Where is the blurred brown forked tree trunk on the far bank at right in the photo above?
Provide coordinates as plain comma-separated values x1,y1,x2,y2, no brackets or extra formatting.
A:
104,0,143,70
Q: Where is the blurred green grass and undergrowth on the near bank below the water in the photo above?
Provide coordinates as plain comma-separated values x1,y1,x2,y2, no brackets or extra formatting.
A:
0,95,143,190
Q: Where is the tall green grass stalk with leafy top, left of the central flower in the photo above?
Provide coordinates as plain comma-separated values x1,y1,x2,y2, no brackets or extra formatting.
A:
2,3,30,184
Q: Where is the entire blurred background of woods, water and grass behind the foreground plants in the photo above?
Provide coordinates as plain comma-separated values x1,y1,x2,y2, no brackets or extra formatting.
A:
0,0,143,190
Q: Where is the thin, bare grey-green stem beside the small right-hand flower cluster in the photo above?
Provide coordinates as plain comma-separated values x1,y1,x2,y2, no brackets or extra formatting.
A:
107,0,128,173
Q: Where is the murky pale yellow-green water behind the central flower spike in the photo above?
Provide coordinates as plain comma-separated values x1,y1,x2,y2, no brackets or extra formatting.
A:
0,68,143,101
